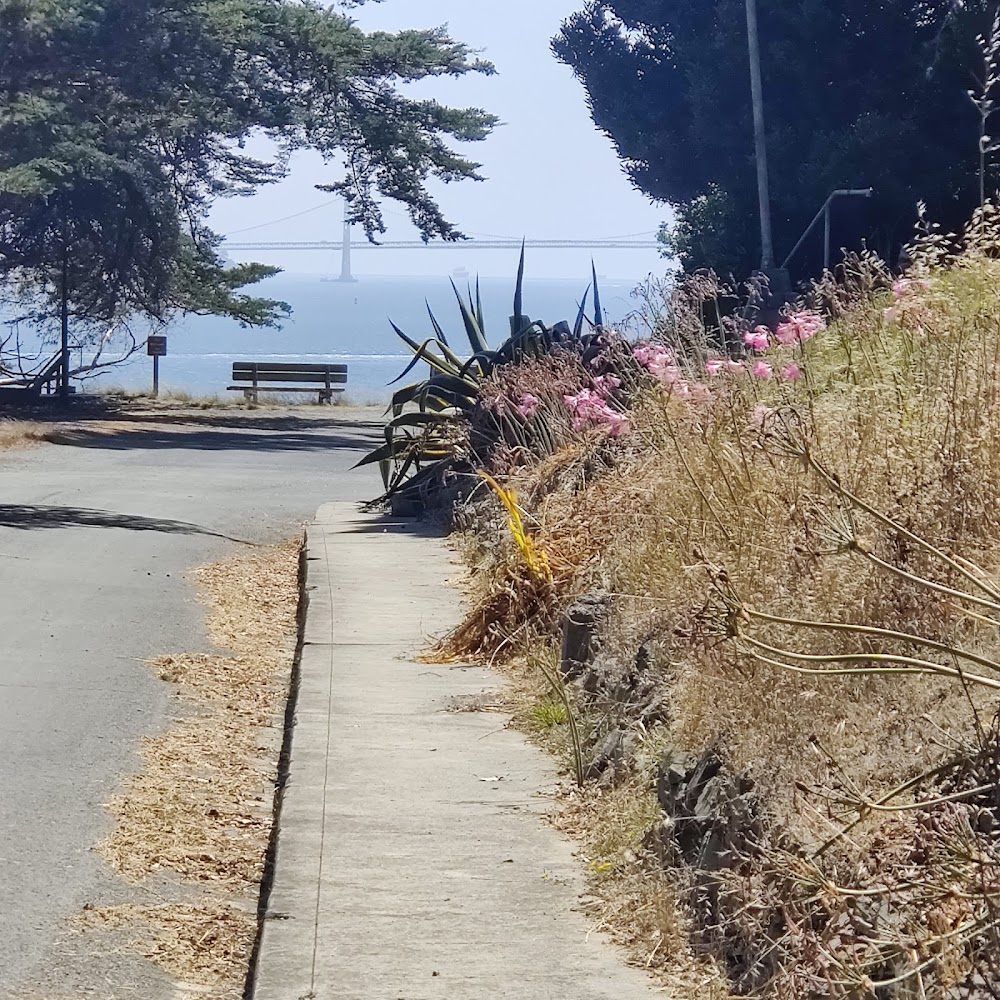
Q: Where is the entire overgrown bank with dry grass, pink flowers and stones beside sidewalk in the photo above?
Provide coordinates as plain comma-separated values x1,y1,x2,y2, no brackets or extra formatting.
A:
422,208,1000,997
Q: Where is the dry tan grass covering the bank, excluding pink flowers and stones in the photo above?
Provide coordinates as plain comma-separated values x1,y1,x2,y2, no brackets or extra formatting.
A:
449,215,1000,997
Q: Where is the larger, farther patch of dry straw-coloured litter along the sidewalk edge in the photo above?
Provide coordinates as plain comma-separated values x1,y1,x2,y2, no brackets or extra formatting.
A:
102,542,299,886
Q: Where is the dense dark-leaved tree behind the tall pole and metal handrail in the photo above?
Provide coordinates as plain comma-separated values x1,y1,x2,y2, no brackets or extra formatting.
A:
553,0,992,274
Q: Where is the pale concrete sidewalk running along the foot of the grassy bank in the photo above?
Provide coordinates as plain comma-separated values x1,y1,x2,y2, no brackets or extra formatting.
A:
254,504,656,1000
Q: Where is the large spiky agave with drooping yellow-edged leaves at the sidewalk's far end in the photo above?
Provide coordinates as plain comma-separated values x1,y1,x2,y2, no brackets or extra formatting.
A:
359,246,604,501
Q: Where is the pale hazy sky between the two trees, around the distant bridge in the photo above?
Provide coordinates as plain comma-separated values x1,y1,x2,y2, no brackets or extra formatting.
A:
213,0,666,279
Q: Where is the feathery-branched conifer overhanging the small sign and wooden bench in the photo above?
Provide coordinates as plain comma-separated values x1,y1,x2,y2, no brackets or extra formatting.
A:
0,0,496,386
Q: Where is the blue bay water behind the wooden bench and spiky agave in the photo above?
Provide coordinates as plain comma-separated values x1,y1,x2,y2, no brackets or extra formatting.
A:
74,274,635,403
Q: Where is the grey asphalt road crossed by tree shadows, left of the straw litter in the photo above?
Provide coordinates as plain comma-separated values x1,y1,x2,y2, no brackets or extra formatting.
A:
0,410,380,998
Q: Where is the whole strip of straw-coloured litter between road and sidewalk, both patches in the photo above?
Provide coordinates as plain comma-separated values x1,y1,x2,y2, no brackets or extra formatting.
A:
79,540,301,998
